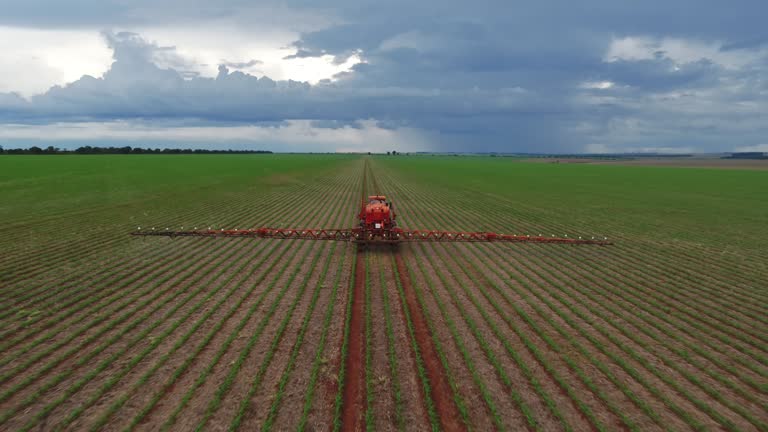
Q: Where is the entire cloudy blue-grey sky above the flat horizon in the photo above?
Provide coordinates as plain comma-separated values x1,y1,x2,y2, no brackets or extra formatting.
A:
0,0,768,153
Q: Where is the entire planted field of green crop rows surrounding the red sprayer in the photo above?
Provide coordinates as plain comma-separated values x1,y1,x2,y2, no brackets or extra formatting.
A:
0,155,768,431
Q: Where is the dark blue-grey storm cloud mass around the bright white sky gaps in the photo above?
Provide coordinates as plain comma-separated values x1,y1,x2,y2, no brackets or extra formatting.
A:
0,0,768,151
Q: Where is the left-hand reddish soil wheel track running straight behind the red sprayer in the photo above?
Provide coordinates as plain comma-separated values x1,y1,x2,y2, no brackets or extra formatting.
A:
342,251,366,431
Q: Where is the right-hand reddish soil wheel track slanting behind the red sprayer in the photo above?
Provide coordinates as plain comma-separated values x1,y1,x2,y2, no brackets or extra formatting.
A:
395,254,466,431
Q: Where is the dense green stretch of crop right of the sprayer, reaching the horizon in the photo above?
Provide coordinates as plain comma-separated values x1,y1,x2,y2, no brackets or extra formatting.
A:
382,157,768,252
